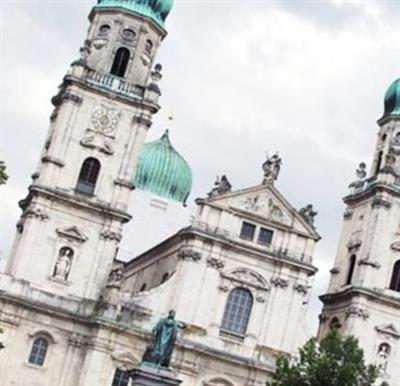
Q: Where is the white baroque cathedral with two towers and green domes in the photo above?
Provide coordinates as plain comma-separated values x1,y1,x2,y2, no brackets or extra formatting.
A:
0,0,400,386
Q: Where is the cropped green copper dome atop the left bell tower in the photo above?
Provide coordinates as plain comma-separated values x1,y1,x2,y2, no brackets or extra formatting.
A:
97,0,174,28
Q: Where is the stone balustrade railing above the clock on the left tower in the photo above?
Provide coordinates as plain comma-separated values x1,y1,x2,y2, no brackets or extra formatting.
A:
83,69,144,98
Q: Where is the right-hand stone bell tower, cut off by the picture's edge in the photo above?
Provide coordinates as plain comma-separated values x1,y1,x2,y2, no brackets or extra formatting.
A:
319,79,400,386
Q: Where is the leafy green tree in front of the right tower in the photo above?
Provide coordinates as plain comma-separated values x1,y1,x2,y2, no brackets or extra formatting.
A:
267,331,379,386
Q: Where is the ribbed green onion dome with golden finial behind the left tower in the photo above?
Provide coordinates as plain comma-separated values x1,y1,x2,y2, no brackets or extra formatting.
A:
134,130,193,203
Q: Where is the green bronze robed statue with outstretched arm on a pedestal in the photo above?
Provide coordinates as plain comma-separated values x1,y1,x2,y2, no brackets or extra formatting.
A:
142,310,186,369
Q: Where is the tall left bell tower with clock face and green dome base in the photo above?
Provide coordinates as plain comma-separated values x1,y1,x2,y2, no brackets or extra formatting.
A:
6,0,172,299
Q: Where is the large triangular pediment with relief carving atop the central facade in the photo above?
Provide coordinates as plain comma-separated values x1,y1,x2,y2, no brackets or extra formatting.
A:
207,184,319,239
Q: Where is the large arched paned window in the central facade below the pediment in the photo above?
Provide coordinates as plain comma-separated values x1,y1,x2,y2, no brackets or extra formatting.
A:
221,288,253,336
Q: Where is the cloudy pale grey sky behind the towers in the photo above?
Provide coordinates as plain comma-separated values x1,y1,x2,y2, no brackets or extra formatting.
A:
0,0,400,329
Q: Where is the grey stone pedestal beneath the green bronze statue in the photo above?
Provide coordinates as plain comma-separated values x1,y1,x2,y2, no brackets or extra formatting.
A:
130,364,182,386
